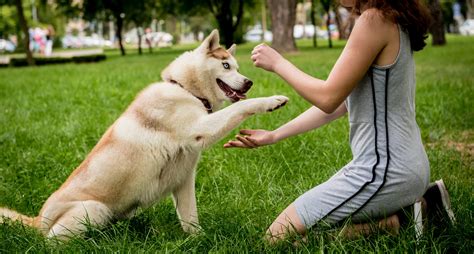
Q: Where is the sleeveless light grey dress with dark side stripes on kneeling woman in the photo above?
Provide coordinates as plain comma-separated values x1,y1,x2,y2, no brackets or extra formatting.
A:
293,25,430,227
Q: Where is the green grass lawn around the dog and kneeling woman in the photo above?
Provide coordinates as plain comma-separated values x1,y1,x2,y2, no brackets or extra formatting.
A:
0,37,474,253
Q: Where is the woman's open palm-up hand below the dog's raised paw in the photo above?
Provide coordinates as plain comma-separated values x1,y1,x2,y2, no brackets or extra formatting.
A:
224,130,276,148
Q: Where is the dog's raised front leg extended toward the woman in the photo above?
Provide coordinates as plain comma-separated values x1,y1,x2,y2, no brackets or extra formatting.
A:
191,95,288,148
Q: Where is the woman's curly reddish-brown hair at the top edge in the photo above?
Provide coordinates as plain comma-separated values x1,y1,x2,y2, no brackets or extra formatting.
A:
352,0,431,51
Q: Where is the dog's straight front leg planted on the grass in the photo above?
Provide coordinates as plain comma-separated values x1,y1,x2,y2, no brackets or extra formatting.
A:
173,170,199,233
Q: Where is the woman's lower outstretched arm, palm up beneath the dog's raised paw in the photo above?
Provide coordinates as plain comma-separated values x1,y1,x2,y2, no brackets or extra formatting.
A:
224,103,347,148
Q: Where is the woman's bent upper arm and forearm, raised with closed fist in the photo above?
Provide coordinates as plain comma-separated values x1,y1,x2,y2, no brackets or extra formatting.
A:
252,9,394,113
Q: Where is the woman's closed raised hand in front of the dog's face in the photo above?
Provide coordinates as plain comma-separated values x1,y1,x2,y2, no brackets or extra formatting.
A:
250,43,284,72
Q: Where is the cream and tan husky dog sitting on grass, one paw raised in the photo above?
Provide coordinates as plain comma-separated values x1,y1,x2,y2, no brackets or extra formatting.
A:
0,30,288,239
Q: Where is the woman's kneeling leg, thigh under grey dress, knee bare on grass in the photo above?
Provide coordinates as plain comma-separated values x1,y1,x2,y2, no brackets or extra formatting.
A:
267,161,425,243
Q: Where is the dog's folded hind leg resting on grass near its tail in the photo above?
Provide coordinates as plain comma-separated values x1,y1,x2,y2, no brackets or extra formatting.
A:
47,200,112,240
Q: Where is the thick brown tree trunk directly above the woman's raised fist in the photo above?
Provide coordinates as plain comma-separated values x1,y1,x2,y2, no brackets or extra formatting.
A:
267,0,297,53
